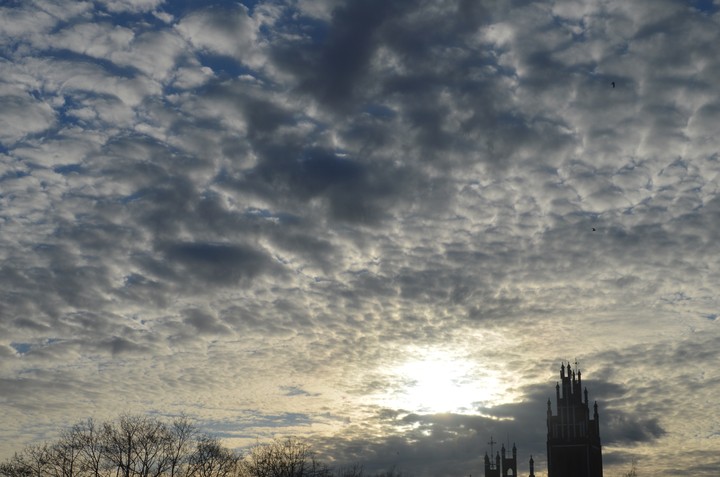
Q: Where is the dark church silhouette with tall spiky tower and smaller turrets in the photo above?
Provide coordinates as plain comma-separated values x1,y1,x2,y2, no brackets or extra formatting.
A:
485,363,603,477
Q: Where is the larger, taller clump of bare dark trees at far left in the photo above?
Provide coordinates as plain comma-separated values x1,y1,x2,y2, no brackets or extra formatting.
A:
0,415,240,477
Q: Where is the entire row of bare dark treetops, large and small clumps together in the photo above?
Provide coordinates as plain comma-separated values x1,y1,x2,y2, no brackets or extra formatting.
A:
0,414,401,477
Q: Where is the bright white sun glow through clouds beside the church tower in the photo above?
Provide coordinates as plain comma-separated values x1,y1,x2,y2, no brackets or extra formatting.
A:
376,349,514,414
